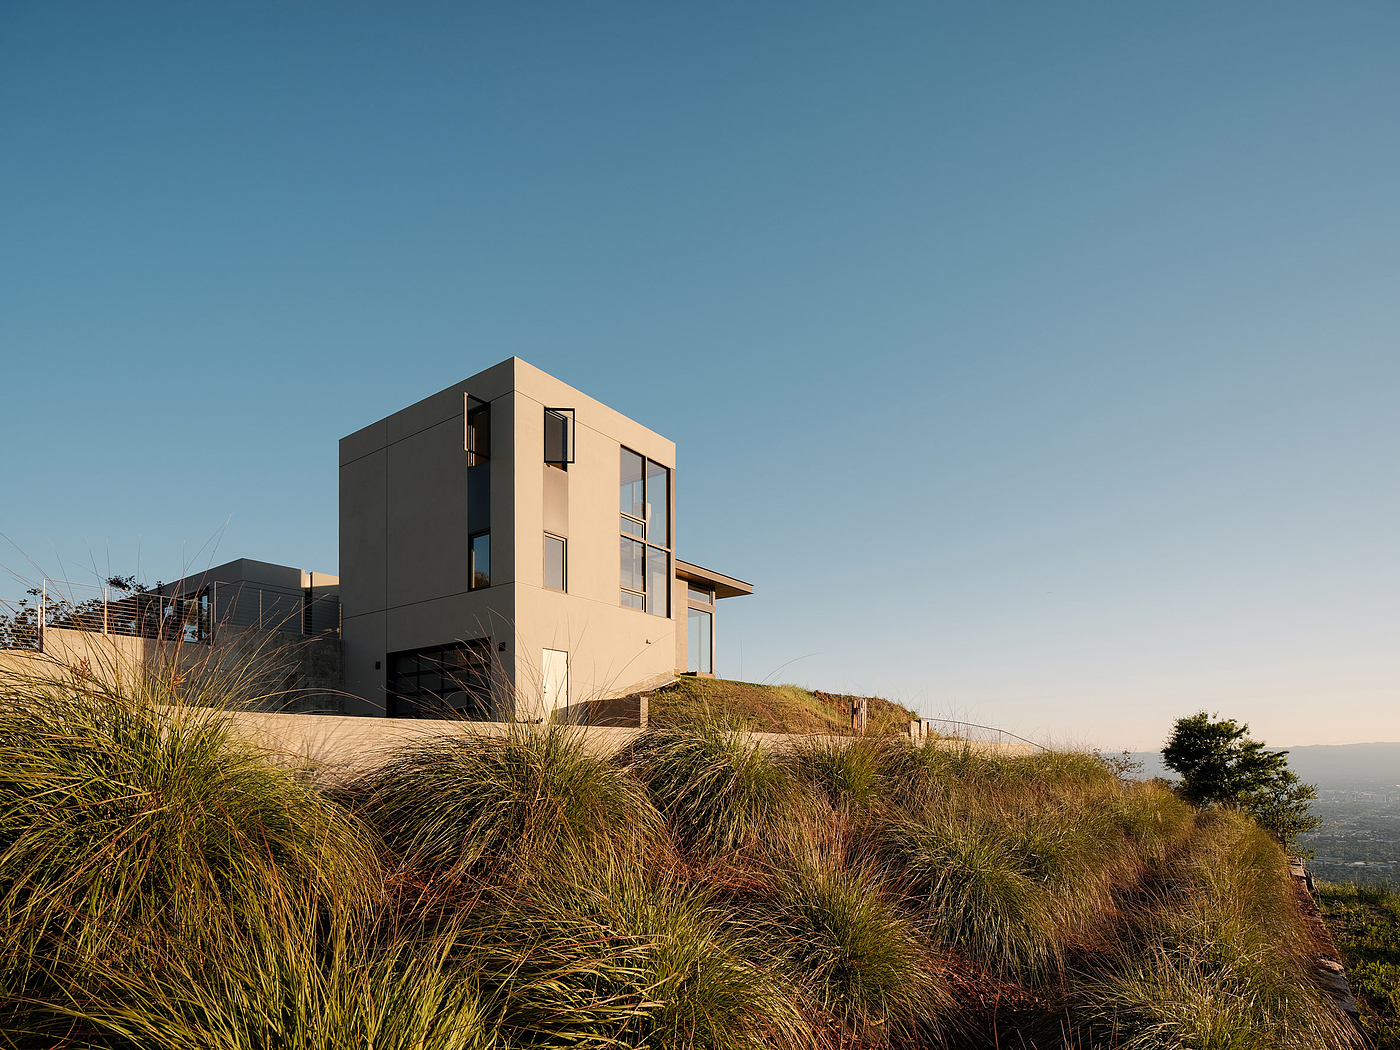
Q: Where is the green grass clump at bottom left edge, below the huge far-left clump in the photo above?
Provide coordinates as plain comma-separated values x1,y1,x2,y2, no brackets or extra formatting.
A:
32,899,503,1050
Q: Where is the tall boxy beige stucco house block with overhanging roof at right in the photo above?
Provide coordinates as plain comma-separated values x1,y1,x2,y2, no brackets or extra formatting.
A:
339,357,753,720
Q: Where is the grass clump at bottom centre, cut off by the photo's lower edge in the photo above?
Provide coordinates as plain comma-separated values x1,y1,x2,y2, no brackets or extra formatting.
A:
480,861,812,1050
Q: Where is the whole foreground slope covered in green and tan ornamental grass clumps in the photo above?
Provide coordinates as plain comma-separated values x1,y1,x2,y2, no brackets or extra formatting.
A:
0,660,1352,1050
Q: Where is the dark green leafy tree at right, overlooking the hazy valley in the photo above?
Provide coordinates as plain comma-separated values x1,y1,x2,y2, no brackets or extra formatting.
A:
1162,711,1322,848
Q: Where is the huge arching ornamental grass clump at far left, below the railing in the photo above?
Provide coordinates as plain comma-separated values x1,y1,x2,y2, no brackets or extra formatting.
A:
0,686,382,1019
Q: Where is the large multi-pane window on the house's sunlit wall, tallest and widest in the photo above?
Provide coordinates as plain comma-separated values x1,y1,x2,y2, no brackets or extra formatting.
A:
619,448,671,616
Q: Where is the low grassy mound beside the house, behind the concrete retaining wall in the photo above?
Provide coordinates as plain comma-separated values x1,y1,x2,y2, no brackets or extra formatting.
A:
648,678,918,735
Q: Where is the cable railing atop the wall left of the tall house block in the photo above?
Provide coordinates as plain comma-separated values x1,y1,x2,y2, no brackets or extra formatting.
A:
0,580,340,650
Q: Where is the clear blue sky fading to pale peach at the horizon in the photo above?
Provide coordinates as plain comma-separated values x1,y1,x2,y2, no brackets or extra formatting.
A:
0,0,1400,749
